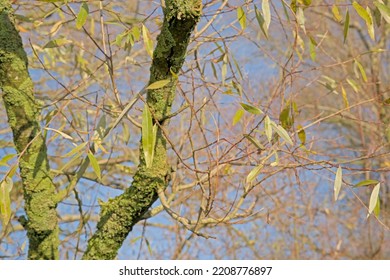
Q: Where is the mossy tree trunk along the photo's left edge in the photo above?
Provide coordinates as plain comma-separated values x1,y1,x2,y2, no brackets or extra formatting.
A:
0,0,59,259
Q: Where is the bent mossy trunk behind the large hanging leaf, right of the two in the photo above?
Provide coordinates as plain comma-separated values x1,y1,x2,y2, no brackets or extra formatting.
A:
83,0,202,259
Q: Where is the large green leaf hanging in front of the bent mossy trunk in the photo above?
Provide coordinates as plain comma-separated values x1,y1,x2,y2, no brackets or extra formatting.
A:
142,104,156,168
